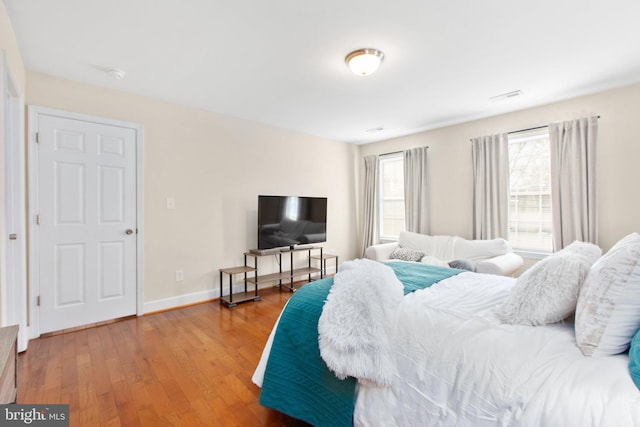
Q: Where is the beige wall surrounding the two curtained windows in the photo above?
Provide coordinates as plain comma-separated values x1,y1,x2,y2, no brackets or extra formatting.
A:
358,85,640,254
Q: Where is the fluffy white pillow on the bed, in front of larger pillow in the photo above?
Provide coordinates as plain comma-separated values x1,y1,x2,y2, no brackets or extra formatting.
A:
496,242,602,326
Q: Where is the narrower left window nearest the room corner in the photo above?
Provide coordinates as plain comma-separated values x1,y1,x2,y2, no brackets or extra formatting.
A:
378,153,405,240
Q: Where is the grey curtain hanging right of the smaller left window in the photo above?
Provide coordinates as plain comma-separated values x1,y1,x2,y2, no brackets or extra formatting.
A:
403,147,429,234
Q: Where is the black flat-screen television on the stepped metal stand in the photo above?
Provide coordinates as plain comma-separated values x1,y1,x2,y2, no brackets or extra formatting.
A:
258,196,327,249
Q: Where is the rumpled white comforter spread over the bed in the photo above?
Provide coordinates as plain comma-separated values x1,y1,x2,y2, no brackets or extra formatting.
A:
354,273,640,427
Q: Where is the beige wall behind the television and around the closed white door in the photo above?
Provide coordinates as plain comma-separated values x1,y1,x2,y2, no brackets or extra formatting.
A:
27,72,357,302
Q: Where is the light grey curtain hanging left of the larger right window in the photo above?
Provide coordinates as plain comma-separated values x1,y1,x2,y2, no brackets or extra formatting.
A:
471,133,509,239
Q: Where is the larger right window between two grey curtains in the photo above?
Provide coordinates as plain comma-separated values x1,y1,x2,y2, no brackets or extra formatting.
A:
508,127,553,252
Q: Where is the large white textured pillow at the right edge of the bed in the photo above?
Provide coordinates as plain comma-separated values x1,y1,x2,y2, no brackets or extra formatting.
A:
575,233,640,356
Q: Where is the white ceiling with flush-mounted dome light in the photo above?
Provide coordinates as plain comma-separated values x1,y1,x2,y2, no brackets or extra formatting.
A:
4,0,640,143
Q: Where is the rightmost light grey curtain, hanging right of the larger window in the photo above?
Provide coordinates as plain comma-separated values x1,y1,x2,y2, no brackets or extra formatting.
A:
549,117,598,250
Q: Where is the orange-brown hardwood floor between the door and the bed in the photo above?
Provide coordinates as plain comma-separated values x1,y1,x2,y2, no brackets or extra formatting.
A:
18,288,306,427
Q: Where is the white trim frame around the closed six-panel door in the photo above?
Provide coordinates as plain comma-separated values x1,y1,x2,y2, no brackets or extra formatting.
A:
27,105,144,338
